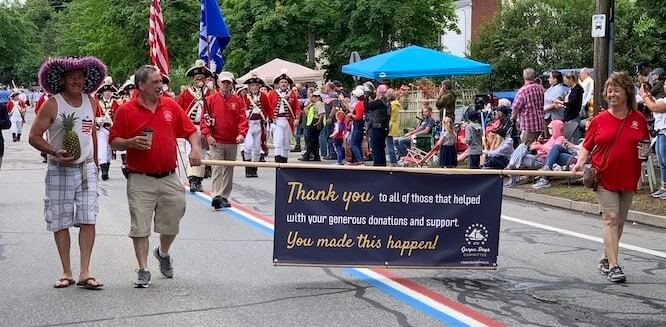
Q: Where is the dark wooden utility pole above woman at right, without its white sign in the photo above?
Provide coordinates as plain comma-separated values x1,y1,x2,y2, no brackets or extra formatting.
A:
594,0,614,115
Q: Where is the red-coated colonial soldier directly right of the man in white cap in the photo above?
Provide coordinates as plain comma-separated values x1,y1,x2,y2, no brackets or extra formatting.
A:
242,73,270,177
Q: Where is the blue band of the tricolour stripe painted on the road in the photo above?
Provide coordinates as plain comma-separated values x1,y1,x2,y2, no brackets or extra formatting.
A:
187,192,469,327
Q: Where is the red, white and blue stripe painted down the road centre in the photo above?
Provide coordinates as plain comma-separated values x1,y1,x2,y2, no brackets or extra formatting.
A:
184,184,504,326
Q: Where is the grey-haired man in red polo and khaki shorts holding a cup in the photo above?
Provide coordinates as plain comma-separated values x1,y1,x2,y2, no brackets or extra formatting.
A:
109,65,201,288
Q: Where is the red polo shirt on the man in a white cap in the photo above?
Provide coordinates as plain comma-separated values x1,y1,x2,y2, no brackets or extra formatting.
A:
201,93,248,144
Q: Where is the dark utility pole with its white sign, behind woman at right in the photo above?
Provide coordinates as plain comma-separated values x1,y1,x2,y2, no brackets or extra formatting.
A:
592,0,615,114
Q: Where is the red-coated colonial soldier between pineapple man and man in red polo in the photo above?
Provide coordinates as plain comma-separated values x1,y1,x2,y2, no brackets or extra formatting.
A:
95,76,118,181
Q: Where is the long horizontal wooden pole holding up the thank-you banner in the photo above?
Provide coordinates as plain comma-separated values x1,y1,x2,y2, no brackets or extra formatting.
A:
201,160,583,178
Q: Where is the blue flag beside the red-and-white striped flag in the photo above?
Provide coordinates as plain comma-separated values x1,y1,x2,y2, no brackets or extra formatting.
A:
199,0,231,73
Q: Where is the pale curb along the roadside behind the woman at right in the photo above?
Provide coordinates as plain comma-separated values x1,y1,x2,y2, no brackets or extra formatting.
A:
503,188,666,228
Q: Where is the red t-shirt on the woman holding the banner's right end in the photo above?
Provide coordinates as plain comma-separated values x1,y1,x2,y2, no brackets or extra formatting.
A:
583,110,650,192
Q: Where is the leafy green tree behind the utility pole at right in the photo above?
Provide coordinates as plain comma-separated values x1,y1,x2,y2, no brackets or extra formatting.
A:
470,0,666,90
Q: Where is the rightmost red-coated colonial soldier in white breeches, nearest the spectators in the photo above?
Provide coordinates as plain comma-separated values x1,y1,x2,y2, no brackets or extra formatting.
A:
268,70,301,163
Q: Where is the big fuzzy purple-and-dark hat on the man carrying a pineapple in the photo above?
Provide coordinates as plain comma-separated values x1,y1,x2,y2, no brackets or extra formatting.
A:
38,57,106,94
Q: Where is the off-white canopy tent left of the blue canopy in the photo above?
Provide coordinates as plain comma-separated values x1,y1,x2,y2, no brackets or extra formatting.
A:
236,58,325,84
